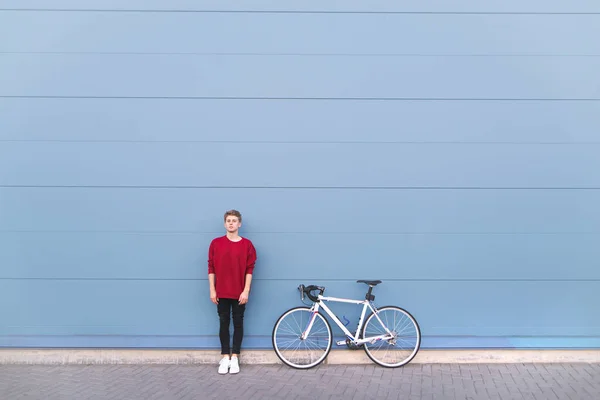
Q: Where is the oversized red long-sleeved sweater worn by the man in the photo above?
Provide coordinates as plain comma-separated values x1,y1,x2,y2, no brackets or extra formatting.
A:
208,236,256,300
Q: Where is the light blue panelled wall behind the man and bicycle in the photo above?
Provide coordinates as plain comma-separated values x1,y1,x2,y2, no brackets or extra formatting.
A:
0,0,600,349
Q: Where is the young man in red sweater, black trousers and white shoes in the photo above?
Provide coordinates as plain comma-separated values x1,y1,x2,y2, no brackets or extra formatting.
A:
208,210,256,374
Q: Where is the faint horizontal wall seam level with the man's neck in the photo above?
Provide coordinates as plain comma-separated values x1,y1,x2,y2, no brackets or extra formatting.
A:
0,229,600,236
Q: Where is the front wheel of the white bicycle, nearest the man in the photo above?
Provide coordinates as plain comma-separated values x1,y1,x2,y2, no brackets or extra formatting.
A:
272,307,333,369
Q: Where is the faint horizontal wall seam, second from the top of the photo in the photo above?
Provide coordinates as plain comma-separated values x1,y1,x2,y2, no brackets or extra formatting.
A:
0,51,600,58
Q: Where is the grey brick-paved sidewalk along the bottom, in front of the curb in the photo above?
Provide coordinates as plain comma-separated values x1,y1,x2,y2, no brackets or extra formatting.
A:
0,364,600,400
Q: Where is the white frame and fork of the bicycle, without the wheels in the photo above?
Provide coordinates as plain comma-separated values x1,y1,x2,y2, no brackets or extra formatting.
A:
300,294,394,346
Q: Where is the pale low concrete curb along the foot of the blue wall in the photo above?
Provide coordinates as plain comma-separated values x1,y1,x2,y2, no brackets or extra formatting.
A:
0,349,600,365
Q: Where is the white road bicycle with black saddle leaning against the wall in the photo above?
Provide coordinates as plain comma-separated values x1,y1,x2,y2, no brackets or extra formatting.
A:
272,280,421,369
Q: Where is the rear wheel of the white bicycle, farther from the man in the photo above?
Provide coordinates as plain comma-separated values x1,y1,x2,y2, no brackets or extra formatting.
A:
362,306,421,368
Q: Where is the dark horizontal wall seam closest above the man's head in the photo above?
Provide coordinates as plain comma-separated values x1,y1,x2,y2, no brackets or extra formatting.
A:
0,185,600,190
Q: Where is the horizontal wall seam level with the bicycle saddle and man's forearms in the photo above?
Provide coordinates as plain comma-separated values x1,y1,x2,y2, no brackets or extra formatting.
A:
0,274,600,284
